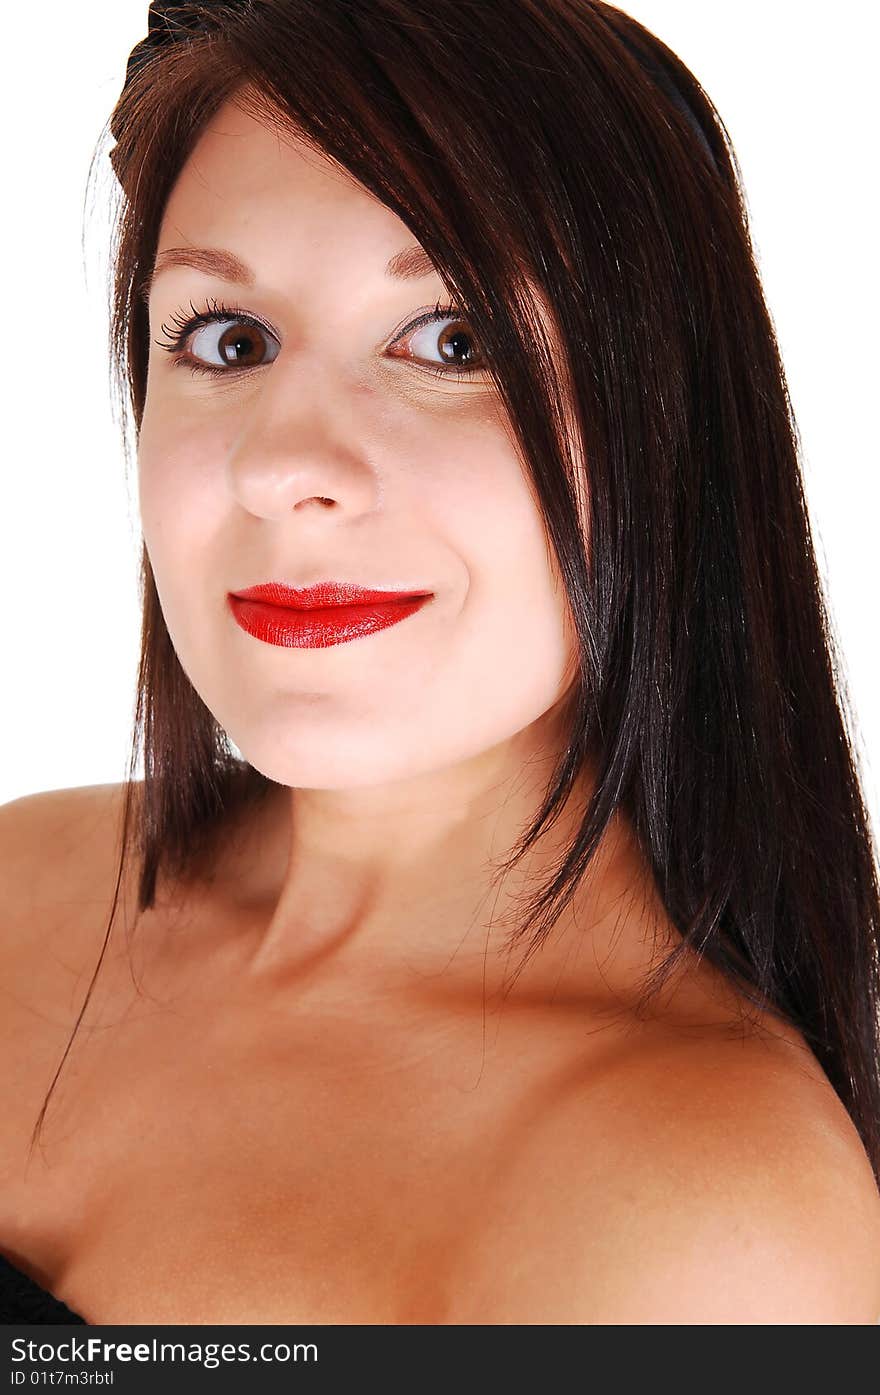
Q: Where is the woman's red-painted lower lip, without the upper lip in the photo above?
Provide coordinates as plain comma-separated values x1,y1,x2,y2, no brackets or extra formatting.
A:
229,596,431,649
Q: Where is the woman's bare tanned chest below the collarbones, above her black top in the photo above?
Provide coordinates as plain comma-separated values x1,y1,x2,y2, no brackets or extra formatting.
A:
0,976,621,1324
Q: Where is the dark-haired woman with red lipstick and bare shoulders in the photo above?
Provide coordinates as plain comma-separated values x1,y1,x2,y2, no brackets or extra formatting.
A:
0,0,880,1324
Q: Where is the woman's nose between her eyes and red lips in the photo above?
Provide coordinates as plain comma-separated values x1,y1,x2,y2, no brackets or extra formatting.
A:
227,357,379,519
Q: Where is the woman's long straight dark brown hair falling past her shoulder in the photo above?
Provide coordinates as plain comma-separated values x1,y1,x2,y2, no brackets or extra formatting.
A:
35,0,880,1179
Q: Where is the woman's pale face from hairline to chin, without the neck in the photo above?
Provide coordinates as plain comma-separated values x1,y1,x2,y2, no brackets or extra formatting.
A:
138,102,575,790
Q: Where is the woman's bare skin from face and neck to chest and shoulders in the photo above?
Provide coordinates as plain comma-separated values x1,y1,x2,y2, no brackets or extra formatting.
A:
0,92,880,1324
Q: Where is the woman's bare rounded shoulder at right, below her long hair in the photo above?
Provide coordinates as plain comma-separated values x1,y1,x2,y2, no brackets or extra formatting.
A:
479,1036,880,1324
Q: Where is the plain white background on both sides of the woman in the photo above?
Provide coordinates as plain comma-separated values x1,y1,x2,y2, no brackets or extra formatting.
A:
0,0,880,837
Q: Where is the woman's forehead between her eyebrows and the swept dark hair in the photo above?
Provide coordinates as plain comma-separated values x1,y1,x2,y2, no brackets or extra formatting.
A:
159,99,414,283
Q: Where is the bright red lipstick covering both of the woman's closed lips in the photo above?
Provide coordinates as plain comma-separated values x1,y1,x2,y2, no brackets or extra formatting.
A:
229,582,432,649
